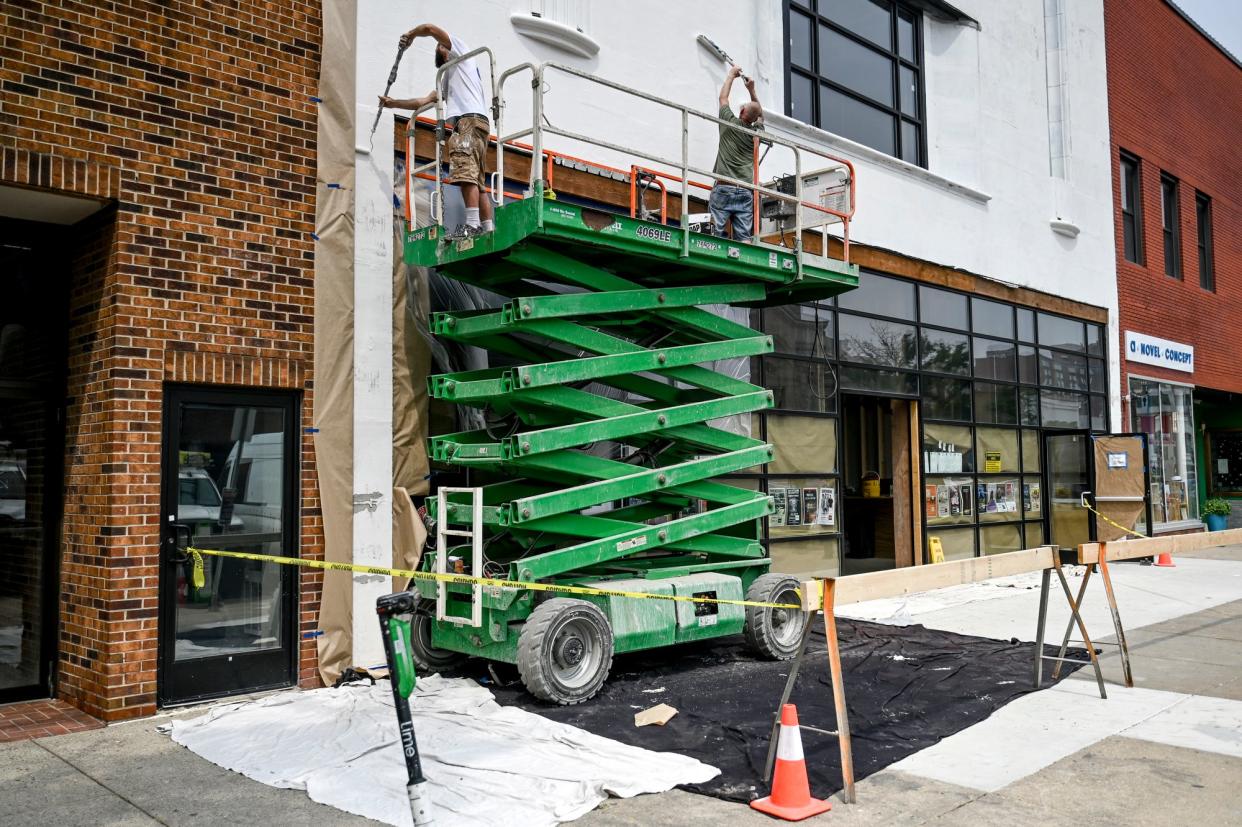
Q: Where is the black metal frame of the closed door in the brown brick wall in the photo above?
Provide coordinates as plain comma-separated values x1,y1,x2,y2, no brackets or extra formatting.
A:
156,384,301,707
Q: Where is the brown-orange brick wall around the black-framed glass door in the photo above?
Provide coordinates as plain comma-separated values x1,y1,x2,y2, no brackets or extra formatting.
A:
0,0,323,720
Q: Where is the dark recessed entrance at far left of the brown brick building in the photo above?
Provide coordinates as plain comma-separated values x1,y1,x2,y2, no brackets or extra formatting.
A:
0,220,68,703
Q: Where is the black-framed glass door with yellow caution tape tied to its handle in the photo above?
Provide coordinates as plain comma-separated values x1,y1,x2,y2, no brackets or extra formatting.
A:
159,387,298,704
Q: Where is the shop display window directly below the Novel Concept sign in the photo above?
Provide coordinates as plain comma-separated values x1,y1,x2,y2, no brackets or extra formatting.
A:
1130,376,1199,529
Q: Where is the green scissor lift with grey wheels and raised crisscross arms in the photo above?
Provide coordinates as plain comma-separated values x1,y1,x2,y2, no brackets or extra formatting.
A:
405,194,858,704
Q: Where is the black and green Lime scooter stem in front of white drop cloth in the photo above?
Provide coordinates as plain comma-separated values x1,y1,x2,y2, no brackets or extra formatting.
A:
375,591,435,827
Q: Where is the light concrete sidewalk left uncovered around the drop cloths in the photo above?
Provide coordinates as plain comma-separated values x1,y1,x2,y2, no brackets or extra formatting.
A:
0,546,1242,827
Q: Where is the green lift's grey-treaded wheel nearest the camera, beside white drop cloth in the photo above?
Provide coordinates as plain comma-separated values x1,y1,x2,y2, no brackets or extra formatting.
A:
518,597,614,707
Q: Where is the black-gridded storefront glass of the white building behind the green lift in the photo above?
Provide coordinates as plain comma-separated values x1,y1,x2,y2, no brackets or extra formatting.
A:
751,266,1107,570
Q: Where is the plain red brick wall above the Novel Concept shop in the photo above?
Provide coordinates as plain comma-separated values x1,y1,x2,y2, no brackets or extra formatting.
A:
1104,0,1242,402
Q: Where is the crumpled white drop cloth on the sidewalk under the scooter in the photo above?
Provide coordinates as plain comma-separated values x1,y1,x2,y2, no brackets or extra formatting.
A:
171,676,720,827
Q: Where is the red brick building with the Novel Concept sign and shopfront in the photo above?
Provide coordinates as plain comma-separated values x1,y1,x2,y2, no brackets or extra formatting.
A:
1104,0,1242,529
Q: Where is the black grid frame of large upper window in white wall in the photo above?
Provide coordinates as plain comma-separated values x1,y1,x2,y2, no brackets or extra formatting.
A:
781,0,928,169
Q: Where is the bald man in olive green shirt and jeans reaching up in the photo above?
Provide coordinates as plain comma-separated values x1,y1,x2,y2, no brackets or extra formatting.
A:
708,66,764,241
